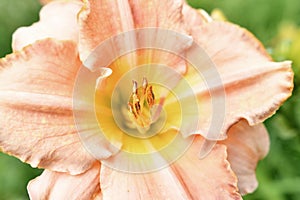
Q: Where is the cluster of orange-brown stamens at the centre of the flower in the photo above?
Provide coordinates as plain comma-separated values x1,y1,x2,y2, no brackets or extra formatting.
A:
128,77,155,133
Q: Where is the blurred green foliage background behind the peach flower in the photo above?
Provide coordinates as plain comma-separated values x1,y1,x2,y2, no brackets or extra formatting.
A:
0,0,300,200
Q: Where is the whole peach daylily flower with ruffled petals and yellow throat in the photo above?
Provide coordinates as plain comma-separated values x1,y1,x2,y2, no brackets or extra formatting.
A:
0,0,293,199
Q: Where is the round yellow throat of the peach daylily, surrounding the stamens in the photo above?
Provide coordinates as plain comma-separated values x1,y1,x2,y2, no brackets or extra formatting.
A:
94,60,190,158
